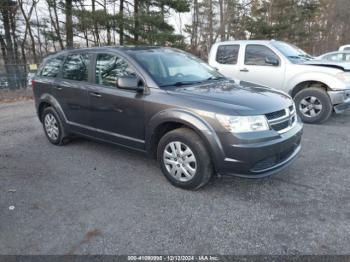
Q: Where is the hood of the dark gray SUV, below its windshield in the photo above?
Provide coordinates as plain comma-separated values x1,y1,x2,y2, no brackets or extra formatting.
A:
169,80,292,115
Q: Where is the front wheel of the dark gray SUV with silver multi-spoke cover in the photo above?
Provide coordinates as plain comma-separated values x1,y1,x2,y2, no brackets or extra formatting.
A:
157,128,213,190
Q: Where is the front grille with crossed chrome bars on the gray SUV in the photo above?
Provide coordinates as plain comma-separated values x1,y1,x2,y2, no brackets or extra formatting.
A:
265,105,297,133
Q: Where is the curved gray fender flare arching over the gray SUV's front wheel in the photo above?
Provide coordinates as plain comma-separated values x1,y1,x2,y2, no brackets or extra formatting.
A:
146,109,224,169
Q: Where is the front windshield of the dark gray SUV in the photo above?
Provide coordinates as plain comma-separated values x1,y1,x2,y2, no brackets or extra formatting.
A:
130,49,224,87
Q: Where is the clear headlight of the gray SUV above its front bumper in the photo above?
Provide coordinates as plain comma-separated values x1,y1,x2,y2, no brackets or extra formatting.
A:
216,114,270,133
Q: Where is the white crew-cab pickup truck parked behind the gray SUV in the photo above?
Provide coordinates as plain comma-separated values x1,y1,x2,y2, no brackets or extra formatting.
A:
209,40,350,123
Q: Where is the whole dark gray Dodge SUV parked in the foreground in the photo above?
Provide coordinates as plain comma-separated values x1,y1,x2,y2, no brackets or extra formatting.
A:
33,47,302,189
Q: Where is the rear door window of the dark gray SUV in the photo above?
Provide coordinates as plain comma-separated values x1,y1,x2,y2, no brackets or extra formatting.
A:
62,53,92,81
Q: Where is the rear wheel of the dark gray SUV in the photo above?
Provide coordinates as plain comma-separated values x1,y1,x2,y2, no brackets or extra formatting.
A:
41,107,68,146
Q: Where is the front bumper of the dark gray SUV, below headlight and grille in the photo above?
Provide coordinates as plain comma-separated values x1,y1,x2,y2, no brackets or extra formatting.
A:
216,122,303,178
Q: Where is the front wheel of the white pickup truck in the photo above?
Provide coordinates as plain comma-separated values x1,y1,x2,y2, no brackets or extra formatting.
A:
294,87,333,124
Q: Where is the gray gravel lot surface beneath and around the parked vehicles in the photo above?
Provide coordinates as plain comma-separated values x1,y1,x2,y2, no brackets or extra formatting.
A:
0,101,350,255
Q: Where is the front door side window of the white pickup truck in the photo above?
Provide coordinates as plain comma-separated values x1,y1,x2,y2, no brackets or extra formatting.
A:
244,45,279,66
